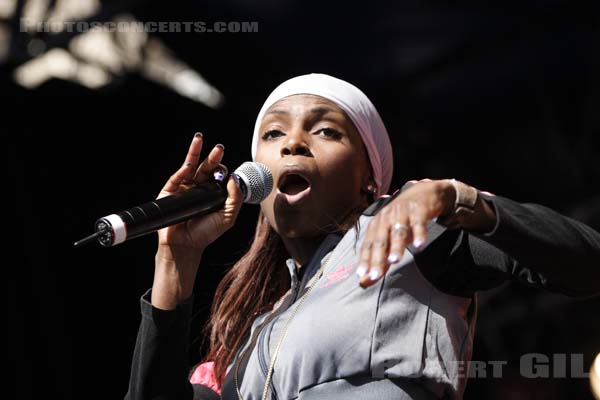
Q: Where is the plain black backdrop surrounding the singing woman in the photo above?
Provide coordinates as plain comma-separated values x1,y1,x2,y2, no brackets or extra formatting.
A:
5,0,600,399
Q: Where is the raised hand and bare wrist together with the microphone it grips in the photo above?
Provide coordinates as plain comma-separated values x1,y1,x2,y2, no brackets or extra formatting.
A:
75,133,273,310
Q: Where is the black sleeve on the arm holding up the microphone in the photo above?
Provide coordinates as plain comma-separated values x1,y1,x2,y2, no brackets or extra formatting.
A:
125,290,219,400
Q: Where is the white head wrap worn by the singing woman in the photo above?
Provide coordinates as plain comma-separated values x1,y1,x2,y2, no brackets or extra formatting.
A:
252,74,394,197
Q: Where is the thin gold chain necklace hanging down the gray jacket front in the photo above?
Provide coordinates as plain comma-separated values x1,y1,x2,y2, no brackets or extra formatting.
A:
235,250,333,400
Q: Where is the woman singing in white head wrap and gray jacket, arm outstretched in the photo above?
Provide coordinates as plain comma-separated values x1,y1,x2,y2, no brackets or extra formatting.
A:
126,74,600,400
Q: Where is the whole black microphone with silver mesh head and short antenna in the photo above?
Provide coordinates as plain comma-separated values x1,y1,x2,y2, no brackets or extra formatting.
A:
73,161,273,247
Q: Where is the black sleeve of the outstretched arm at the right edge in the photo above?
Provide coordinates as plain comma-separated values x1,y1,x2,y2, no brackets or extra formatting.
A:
416,194,600,297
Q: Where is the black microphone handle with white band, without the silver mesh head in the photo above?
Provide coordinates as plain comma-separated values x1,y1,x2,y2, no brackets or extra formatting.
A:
96,180,227,247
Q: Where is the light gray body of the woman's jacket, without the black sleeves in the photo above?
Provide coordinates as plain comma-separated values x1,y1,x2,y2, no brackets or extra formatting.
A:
223,215,477,400
